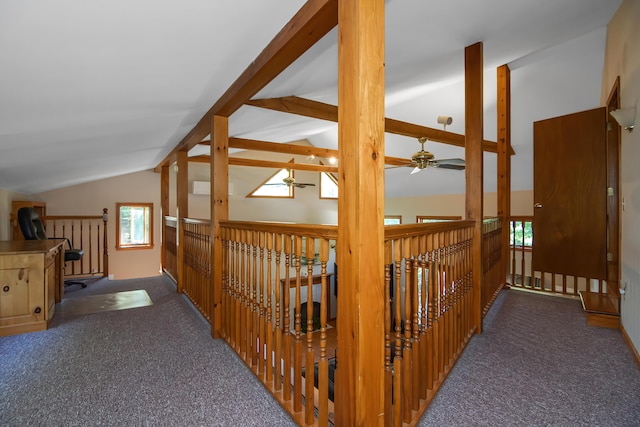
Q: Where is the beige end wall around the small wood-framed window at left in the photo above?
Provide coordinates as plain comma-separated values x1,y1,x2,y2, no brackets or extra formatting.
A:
35,172,161,279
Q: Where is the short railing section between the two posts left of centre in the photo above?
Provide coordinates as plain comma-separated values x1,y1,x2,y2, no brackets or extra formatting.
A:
178,218,213,323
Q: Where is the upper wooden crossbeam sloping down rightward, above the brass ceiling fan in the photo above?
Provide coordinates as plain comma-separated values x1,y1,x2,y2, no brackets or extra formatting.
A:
246,96,515,154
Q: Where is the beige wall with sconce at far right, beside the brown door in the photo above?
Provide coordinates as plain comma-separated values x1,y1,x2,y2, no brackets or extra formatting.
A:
601,0,640,350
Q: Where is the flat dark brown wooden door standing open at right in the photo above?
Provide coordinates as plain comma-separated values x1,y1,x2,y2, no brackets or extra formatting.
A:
532,108,607,280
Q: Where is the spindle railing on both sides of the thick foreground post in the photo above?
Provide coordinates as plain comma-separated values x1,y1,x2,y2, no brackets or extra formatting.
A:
220,221,482,426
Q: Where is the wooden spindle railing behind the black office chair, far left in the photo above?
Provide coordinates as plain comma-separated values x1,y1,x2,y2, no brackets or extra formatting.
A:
41,208,109,277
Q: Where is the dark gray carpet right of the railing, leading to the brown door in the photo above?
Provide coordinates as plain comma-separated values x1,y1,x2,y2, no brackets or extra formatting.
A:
419,290,640,427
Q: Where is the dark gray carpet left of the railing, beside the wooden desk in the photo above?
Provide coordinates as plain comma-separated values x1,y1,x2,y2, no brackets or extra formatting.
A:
0,277,295,426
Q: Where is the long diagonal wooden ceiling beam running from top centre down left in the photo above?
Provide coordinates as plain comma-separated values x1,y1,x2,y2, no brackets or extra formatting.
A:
156,0,338,169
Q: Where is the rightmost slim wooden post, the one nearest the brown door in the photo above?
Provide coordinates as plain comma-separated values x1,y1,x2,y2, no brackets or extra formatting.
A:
496,64,511,290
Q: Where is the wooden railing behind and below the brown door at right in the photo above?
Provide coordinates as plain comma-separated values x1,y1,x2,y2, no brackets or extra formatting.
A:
507,216,607,296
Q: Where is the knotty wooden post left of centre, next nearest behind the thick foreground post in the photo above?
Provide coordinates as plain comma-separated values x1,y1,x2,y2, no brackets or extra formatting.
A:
210,116,229,338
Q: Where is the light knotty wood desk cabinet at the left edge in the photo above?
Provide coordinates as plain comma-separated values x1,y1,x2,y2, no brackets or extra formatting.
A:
0,239,64,336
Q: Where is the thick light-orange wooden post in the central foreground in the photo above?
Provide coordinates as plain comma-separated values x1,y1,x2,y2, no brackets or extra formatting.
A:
335,0,384,426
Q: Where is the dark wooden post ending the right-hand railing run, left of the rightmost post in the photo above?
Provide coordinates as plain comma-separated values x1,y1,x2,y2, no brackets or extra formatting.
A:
464,42,483,333
